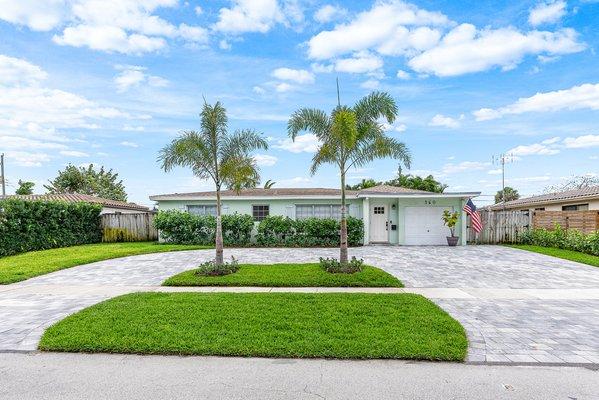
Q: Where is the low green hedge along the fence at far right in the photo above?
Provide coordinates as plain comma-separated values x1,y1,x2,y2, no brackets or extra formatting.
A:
520,225,599,256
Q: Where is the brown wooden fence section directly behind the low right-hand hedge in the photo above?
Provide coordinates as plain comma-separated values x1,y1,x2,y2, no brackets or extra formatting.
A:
532,210,599,233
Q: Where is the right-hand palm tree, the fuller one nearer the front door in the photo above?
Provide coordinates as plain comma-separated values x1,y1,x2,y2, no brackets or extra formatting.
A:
287,92,411,264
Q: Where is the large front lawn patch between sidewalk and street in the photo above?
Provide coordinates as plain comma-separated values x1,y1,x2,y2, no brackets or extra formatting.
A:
39,293,468,361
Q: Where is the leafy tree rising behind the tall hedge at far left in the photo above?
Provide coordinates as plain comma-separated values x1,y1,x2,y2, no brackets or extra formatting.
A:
44,164,127,201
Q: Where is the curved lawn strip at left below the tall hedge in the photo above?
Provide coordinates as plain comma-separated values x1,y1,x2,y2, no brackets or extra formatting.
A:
0,242,211,285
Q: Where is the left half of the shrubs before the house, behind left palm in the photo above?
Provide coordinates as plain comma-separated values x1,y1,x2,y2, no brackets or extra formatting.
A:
154,210,254,246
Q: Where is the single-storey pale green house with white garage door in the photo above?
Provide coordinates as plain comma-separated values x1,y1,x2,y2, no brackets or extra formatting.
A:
150,185,480,245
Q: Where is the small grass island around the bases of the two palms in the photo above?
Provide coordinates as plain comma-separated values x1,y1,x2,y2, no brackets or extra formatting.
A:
163,264,403,287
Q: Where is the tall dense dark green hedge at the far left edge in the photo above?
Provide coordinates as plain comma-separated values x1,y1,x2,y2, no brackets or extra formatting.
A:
0,199,102,256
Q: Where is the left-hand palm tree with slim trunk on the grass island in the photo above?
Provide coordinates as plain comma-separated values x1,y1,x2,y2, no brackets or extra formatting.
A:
158,102,268,265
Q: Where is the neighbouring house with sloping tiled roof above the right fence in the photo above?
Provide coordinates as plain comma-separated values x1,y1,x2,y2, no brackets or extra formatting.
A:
489,186,599,211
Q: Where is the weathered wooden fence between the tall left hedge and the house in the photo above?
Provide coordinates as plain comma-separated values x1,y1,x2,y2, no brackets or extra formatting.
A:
100,213,158,242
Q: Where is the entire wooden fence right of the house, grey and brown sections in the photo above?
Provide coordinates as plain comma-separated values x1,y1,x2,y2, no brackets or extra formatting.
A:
468,210,599,244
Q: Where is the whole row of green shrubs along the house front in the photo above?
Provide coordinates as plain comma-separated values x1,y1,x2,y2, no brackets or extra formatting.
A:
154,210,364,247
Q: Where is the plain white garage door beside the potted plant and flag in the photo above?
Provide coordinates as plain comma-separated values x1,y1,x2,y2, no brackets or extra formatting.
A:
405,207,450,245
